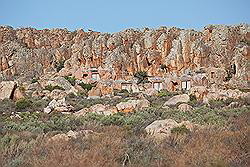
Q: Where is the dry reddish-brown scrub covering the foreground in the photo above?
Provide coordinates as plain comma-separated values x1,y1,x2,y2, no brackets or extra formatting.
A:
0,112,250,167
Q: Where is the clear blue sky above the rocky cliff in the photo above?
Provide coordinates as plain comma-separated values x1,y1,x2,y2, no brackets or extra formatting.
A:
0,0,250,32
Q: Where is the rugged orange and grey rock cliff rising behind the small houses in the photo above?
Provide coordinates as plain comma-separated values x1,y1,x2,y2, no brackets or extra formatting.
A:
0,24,250,87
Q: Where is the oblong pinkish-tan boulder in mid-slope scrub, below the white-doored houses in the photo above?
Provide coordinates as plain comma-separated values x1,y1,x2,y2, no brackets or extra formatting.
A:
116,99,150,112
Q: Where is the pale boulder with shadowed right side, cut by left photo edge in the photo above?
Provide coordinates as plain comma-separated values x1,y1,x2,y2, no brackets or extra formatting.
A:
0,81,16,100
